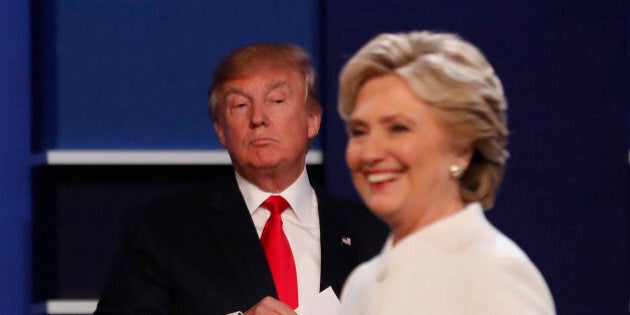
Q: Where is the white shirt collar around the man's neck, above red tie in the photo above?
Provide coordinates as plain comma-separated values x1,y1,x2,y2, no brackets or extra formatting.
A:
235,168,315,224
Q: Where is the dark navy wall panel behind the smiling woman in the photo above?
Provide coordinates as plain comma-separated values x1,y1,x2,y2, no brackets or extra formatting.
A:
324,0,630,314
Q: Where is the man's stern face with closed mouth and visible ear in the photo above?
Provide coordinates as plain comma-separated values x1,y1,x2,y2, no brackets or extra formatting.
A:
214,66,321,181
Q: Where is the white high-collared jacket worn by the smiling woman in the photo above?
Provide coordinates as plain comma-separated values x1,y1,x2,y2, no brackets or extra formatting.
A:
340,203,555,315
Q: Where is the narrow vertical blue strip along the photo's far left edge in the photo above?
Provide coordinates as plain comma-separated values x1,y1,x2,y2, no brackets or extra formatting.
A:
0,0,31,315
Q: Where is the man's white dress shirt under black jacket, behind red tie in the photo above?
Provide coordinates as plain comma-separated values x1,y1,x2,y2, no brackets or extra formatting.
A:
236,168,321,305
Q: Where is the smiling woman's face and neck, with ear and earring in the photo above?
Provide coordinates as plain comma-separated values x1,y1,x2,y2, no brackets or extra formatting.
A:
346,74,470,240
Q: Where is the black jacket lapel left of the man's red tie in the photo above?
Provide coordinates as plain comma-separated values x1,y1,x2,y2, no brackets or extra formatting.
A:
209,175,276,306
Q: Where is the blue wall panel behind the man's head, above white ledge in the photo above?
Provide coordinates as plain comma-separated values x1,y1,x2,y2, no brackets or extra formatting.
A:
47,0,319,149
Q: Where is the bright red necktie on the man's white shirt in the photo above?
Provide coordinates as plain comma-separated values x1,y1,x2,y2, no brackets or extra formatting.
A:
260,196,298,309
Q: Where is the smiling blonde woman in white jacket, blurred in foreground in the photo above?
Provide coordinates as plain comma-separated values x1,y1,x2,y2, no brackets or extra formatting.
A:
339,31,555,315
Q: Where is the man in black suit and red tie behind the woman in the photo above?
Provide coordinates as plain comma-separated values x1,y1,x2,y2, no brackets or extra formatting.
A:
95,44,387,314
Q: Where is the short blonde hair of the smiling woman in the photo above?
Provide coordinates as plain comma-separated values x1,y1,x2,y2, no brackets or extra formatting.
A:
338,31,509,209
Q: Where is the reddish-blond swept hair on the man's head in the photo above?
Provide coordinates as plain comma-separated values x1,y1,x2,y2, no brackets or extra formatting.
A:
209,43,321,121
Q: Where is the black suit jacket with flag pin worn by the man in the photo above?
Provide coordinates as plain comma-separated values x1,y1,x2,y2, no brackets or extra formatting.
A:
95,174,387,315
